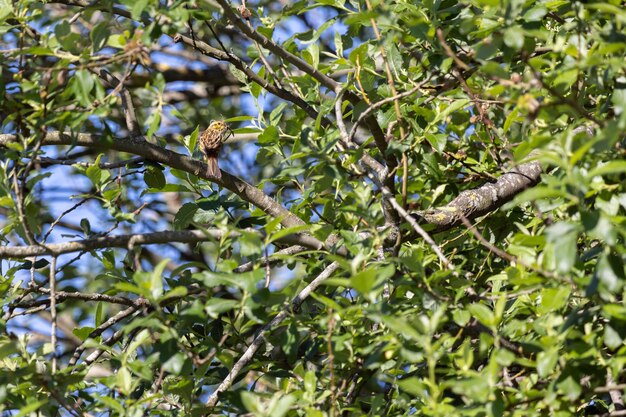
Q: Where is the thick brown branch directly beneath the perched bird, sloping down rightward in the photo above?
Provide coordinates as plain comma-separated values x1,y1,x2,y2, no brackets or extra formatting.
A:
0,132,305,227
